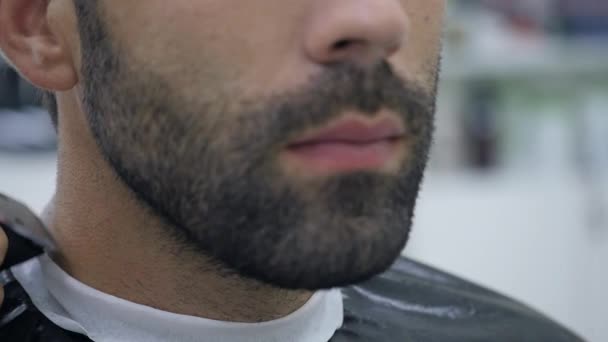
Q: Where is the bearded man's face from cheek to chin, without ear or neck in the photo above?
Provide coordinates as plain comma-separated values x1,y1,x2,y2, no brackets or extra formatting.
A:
74,0,444,289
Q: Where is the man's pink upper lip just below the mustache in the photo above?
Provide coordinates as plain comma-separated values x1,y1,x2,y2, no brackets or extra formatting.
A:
290,118,405,146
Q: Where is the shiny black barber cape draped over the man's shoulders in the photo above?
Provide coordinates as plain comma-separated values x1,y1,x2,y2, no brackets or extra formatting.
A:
0,258,582,342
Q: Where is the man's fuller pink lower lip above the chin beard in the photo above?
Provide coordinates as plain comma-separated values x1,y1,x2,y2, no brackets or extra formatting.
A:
287,139,401,173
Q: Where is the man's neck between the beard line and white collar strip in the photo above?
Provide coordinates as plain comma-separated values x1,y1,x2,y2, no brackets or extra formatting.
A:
47,94,312,322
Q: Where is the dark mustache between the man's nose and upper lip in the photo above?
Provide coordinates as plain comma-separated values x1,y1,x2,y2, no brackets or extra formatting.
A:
234,62,436,148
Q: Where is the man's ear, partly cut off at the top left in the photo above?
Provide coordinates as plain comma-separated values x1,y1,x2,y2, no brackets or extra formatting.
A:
0,0,78,91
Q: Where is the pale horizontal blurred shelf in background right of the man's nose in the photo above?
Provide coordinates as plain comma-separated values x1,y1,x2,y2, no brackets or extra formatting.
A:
442,37,608,82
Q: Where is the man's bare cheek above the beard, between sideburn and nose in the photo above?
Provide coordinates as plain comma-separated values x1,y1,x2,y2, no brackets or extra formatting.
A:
104,0,310,101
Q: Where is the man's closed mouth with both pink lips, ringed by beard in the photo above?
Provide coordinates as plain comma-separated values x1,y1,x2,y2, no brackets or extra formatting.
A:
285,115,406,174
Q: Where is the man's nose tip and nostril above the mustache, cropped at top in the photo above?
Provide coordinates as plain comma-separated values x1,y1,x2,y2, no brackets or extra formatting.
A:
304,0,407,65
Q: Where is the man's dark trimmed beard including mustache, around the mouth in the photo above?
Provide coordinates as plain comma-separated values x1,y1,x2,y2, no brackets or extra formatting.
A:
79,5,435,290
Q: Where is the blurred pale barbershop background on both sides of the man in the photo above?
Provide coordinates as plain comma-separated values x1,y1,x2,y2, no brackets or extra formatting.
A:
0,0,608,342
